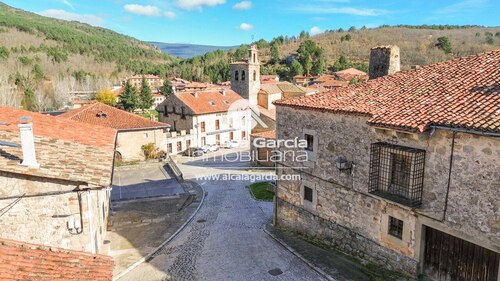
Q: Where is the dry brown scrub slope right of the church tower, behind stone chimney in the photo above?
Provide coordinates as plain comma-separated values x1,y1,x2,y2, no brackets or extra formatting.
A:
261,26,500,69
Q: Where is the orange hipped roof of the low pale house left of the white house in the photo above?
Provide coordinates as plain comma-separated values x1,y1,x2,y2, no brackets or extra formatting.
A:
57,102,170,131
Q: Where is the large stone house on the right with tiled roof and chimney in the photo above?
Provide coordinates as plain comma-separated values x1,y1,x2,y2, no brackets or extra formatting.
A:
275,47,500,281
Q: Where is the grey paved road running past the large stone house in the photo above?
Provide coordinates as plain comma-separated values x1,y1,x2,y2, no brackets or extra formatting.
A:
120,151,323,281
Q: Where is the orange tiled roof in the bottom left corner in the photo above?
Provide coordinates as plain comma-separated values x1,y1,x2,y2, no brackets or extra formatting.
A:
0,239,114,281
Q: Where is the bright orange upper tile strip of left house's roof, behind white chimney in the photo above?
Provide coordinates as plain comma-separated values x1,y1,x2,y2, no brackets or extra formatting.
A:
0,106,116,146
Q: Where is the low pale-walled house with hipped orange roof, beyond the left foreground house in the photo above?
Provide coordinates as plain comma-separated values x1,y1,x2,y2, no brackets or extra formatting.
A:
57,102,170,161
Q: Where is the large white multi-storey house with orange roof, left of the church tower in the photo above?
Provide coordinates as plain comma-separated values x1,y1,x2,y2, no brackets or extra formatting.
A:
156,89,252,154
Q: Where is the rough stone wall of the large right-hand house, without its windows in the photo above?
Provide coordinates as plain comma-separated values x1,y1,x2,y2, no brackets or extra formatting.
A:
276,106,500,275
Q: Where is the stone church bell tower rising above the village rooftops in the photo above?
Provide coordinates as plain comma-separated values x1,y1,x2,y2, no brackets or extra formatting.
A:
230,45,260,105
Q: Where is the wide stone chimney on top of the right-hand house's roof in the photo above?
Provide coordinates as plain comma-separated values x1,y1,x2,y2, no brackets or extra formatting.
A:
368,45,401,79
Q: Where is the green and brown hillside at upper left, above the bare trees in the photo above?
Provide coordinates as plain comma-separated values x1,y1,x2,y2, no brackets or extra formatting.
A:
0,3,175,80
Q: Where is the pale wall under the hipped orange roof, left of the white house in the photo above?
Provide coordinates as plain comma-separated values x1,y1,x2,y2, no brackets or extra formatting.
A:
116,129,167,161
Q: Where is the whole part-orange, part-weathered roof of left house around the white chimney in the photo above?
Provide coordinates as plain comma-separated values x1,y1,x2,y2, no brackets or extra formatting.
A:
0,106,116,188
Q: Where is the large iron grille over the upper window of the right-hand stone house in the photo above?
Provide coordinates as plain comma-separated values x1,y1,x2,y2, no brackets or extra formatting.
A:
368,142,425,207
